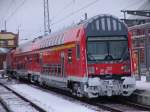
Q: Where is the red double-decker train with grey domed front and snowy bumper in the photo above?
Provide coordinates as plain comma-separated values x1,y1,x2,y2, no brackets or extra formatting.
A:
7,15,135,98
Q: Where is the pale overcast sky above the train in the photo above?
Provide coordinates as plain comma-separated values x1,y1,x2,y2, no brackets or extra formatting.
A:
0,0,148,43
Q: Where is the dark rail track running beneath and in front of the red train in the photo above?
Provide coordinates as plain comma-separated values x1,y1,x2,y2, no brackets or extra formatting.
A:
1,77,150,112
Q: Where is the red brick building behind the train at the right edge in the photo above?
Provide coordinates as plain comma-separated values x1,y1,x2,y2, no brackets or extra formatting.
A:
129,23,150,73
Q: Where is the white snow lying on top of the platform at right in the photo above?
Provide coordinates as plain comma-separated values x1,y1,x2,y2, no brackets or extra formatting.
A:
136,76,150,91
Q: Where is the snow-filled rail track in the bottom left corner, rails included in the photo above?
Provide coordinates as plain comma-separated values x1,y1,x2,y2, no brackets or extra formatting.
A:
0,78,46,112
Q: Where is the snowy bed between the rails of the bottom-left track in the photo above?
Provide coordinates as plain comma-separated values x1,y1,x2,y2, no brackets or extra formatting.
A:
0,86,39,112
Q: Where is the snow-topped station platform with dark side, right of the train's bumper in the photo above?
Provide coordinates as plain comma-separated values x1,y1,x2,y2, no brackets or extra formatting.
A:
129,76,150,106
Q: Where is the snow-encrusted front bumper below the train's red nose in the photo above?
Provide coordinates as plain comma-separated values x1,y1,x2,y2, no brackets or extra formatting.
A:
84,77,136,97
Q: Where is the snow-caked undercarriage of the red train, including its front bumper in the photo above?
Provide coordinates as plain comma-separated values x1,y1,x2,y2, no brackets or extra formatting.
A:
7,71,135,98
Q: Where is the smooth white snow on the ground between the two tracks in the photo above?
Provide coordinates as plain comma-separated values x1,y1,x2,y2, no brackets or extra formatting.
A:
11,84,96,112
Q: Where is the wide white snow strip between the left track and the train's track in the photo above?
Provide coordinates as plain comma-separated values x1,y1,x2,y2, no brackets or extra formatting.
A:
0,80,100,112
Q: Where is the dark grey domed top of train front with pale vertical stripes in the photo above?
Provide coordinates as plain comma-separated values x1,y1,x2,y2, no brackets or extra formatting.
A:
84,14,128,36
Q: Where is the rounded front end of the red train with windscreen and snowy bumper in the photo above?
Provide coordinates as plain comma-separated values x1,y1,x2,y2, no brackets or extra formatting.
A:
85,15,135,97
